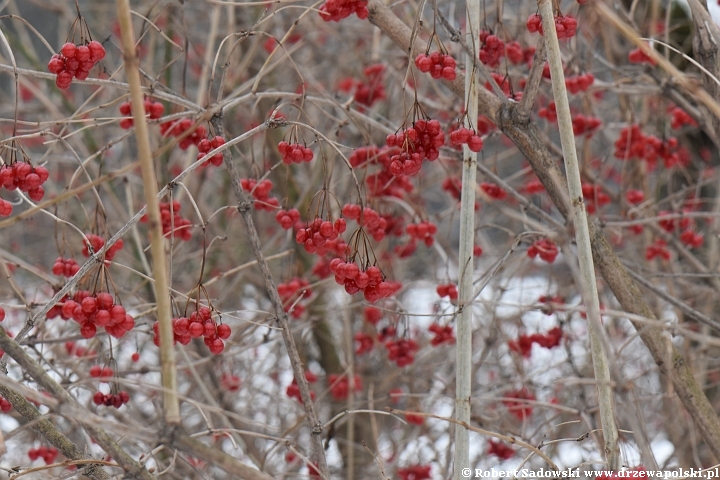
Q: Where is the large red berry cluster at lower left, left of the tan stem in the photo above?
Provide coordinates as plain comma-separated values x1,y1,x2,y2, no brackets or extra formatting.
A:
62,290,135,338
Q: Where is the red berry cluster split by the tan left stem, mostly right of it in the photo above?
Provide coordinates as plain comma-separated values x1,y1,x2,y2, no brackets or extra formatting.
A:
158,307,232,355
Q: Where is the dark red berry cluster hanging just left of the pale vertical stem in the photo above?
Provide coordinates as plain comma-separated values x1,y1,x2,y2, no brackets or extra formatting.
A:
385,119,445,177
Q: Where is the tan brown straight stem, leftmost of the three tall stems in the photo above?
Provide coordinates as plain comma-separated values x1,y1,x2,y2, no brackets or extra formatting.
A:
117,0,180,424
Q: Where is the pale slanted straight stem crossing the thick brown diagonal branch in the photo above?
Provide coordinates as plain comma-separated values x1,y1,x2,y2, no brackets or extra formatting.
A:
538,0,620,471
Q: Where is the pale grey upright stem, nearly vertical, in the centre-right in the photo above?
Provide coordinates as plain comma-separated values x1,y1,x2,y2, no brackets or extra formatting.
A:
454,0,480,480
